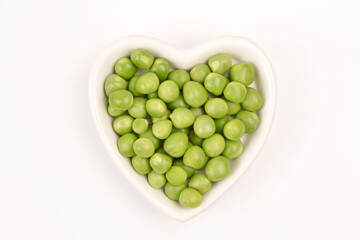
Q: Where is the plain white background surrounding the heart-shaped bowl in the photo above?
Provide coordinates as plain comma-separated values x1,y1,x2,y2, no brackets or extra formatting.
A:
0,0,360,240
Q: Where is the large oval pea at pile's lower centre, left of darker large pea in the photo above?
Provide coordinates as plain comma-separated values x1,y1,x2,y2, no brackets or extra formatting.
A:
164,132,189,158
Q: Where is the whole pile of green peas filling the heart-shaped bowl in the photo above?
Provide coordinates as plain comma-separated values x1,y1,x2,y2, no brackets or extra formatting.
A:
104,48,263,208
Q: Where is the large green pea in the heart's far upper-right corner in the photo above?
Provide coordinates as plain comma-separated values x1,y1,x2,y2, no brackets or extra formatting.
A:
230,63,255,87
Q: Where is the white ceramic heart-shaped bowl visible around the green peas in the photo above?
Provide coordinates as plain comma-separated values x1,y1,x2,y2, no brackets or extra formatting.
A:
89,36,276,221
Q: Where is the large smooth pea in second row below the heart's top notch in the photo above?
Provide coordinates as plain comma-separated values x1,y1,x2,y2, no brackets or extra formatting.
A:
183,81,208,107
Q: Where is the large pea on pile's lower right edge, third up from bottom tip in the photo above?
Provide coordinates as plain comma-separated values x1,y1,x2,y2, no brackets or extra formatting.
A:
205,156,231,182
